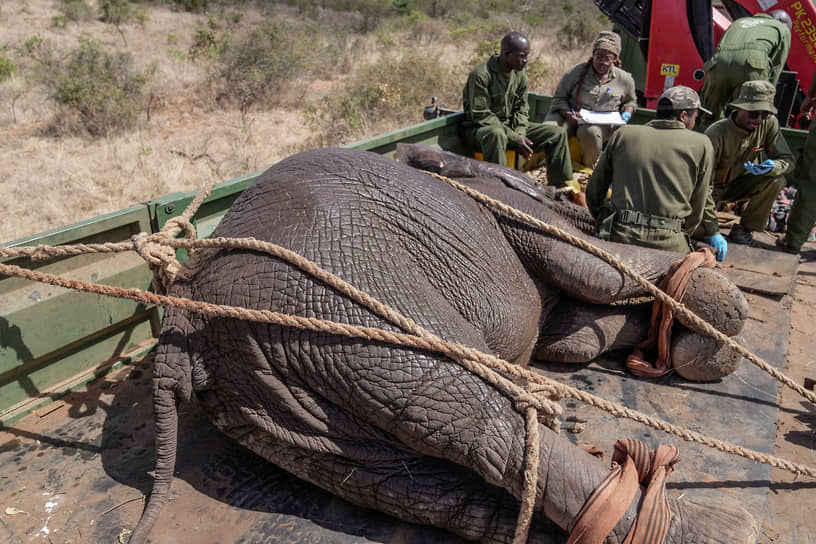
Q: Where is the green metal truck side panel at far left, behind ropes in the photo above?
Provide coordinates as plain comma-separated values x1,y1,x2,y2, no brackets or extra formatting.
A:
0,205,159,422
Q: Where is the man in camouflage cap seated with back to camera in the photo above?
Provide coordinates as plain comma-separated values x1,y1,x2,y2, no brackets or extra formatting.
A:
586,85,728,261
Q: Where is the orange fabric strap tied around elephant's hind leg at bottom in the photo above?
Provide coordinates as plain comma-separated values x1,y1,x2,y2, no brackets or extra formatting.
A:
567,440,680,544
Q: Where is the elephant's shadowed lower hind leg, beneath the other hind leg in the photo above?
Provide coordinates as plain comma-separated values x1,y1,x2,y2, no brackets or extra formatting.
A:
226,432,563,544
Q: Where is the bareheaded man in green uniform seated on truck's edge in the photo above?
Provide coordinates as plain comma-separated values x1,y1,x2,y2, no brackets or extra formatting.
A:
462,32,572,186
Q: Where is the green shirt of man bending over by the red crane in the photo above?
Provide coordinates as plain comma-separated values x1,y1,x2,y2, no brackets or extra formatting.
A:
703,13,791,85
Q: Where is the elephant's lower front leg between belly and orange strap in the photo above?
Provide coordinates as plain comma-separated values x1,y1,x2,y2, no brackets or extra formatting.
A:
533,299,652,363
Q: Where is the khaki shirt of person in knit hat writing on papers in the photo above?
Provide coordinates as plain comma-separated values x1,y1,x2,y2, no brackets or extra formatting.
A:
550,62,637,113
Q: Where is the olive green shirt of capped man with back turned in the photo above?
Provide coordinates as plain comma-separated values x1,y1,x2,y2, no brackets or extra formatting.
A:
586,119,719,235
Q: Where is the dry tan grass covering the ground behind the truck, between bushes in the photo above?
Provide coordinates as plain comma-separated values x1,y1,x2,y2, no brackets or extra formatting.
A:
0,0,600,241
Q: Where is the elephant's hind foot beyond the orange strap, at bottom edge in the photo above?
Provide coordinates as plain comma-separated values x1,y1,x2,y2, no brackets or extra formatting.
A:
666,499,758,544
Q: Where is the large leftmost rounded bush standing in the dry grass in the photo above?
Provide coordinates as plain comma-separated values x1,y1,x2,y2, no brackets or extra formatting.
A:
23,36,150,136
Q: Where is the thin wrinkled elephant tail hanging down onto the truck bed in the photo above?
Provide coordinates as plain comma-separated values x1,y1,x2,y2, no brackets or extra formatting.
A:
128,387,178,544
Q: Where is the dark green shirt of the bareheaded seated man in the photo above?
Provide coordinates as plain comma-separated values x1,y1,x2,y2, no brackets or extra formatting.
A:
462,55,530,143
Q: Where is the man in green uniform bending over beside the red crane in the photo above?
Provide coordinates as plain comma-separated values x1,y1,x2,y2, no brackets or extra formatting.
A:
700,10,791,124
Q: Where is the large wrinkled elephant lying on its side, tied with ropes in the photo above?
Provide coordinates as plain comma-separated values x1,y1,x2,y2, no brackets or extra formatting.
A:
131,148,754,543
